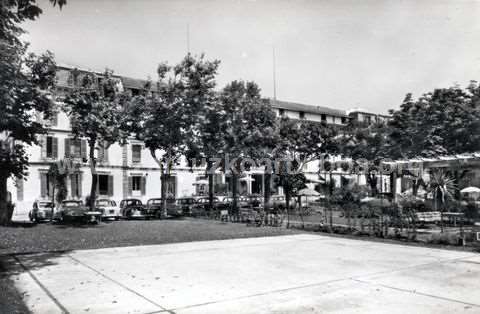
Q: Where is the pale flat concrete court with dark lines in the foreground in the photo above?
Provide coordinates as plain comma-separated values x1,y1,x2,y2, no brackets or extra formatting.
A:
2,234,480,313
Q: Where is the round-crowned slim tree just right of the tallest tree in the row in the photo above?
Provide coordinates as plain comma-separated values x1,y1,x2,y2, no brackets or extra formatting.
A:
219,81,276,215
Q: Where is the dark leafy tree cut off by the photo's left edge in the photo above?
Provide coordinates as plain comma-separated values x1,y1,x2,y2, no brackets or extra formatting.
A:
0,0,65,224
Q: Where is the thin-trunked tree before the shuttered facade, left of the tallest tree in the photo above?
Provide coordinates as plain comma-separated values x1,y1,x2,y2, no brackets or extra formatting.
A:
63,70,128,210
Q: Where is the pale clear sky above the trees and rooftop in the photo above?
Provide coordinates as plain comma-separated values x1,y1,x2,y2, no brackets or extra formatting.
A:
23,0,480,113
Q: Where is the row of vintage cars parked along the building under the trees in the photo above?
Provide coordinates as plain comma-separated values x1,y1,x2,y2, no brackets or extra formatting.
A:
29,195,292,223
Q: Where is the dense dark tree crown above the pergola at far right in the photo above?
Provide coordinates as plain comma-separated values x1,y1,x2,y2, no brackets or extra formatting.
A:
388,81,480,158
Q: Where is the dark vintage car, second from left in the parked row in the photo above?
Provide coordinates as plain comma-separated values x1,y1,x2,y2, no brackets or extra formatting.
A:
53,200,102,223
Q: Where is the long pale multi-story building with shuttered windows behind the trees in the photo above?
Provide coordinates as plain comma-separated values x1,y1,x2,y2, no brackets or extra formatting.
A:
9,66,382,212
